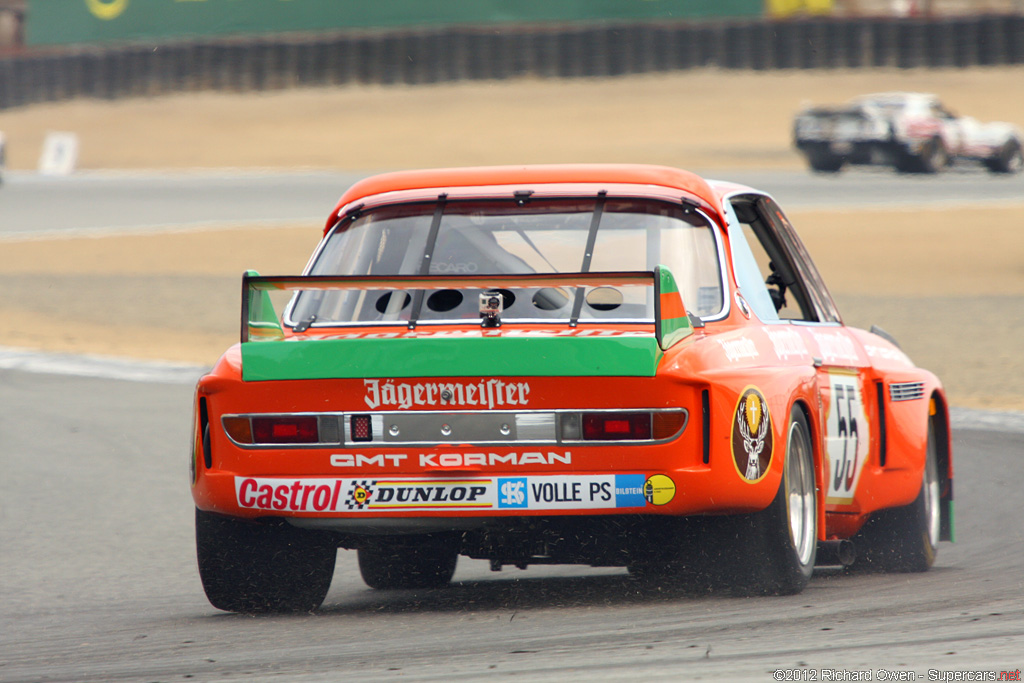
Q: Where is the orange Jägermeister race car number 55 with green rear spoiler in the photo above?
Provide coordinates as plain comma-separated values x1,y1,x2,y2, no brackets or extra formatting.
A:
191,165,952,611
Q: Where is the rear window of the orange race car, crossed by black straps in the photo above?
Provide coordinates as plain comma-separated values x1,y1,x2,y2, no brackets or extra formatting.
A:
285,198,724,327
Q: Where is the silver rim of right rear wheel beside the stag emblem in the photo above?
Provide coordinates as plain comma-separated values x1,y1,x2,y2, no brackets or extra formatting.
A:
784,420,815,566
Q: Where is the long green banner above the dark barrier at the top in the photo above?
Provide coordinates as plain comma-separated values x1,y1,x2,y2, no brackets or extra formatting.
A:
26,0,764,45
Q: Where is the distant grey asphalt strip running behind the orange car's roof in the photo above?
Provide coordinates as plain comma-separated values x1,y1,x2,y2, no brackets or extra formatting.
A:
0,167,1024,241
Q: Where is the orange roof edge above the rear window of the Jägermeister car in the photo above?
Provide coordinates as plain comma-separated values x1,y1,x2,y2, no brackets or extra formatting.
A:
326,164,733,229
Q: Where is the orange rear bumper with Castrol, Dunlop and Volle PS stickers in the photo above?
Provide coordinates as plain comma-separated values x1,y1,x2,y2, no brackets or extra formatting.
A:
193,461,781,530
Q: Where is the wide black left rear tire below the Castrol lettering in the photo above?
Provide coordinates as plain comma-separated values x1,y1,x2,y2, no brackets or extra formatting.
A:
196,509,338,613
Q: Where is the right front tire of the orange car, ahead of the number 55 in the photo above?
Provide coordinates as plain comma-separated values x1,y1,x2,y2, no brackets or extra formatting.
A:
852,420,941,572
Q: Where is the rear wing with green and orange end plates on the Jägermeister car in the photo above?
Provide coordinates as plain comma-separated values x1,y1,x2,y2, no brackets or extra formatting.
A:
241,266,702,350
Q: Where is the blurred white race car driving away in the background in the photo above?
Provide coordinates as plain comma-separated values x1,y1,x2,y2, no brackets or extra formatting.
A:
794,92,1024,173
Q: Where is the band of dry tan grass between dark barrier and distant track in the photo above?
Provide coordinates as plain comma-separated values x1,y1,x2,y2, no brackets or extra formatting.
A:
0,67,1024,170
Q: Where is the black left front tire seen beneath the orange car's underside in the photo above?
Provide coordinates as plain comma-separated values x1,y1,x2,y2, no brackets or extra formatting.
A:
358,537,459,590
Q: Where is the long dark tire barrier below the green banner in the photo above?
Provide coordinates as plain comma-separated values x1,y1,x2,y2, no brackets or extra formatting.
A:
0,14,1024,109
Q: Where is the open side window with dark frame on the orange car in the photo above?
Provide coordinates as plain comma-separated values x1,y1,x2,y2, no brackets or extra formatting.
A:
732,195,819,322
